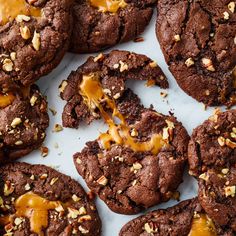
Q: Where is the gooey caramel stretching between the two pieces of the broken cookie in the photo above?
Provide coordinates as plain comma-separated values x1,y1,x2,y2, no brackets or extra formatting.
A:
79,74,167,155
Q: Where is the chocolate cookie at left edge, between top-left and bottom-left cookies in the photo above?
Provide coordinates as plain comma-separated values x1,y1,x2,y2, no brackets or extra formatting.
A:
0,85,49,164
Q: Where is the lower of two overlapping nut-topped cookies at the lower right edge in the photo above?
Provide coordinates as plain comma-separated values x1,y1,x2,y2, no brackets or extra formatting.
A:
198,167,236,235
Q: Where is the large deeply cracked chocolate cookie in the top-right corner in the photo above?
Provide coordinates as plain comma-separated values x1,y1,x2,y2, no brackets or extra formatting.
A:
156,0,236,106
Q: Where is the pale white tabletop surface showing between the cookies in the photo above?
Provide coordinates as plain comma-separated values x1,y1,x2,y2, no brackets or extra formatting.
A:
21,12,226,236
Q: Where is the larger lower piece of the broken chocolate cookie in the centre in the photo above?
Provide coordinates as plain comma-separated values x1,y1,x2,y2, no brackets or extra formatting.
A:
74,90,189,214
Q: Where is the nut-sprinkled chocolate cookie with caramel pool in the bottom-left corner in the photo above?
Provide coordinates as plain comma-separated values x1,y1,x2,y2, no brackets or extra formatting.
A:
0,163,101,236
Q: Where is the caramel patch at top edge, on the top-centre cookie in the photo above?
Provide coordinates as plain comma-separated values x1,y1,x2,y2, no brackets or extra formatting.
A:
89,0,127,13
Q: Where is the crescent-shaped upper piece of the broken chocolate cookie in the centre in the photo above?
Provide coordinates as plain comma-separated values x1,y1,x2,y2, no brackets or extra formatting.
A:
60,51,168,128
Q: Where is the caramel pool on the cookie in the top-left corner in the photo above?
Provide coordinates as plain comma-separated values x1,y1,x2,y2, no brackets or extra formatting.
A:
0,0,41,25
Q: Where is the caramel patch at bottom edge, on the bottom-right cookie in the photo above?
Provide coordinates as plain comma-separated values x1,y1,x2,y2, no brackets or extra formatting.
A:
188,214,217,236
